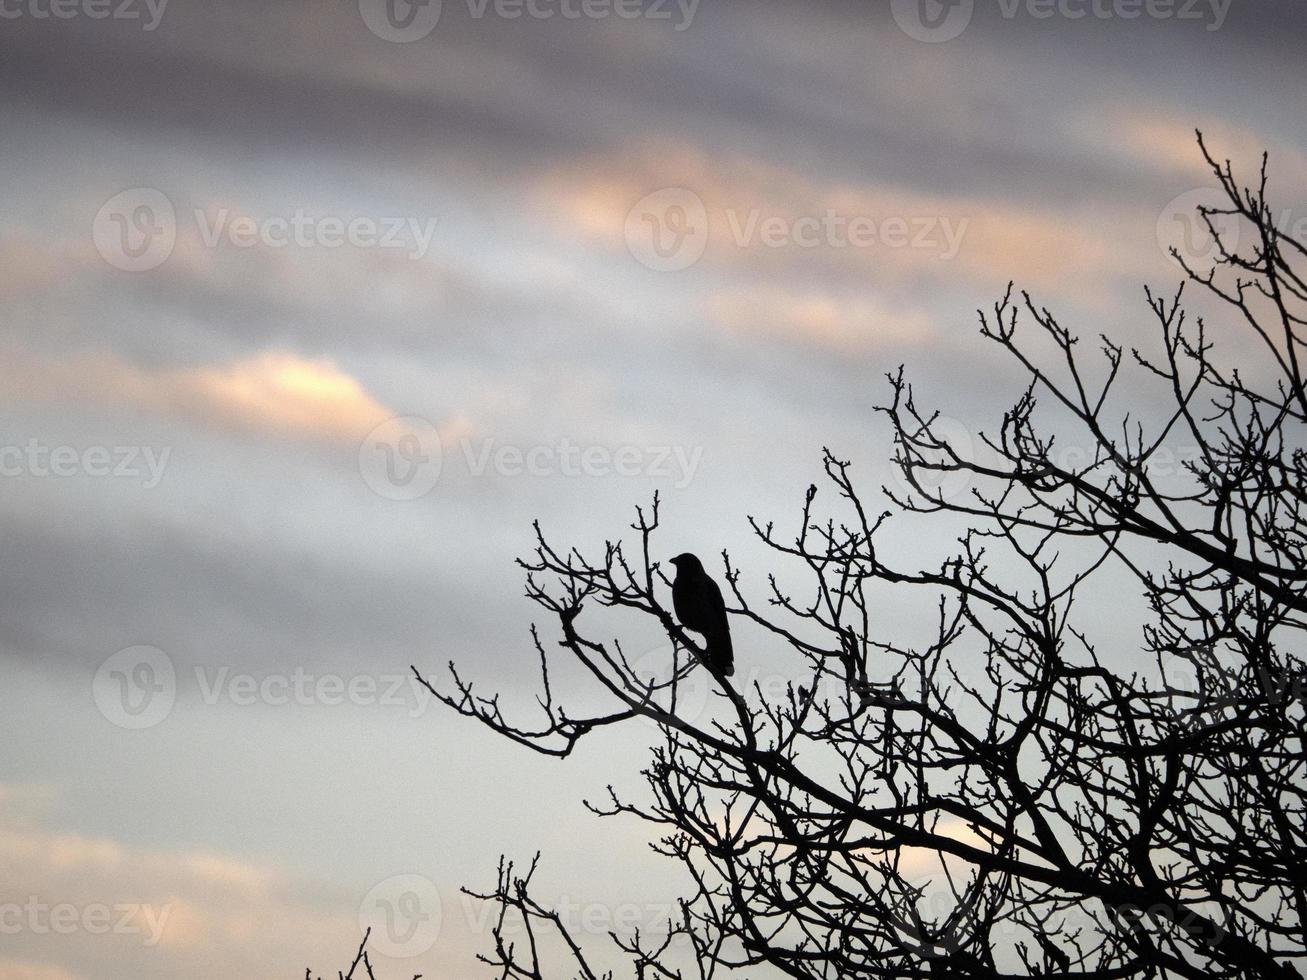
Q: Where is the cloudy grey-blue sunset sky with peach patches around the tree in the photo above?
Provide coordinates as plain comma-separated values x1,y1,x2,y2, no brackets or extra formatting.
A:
0,0,1307,980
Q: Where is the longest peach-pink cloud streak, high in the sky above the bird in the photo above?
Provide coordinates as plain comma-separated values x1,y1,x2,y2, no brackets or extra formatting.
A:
536,144,1154,297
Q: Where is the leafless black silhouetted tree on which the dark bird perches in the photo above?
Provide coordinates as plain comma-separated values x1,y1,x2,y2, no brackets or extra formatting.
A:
326,135,1307,980
